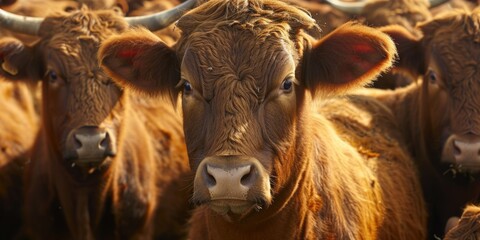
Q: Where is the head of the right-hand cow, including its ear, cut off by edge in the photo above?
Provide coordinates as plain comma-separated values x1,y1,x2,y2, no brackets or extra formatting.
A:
384,10,480,173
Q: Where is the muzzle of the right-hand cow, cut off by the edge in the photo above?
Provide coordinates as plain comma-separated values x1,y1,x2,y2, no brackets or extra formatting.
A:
442,134,480,172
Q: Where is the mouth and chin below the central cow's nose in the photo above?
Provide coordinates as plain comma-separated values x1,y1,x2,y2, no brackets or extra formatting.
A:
206,199,265,222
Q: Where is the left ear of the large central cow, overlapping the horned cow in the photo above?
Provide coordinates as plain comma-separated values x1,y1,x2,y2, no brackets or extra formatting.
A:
98,29,180,102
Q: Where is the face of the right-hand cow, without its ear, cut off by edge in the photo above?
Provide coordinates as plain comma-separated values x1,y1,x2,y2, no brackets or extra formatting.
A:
422,12,480,172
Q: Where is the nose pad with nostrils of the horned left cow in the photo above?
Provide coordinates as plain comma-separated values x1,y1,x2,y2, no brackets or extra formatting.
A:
70,126,116,164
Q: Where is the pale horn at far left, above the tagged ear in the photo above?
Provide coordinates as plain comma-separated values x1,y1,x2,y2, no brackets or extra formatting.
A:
0,9,44,35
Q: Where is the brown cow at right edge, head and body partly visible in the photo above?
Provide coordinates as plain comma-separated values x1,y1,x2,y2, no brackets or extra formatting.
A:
356,9,480,238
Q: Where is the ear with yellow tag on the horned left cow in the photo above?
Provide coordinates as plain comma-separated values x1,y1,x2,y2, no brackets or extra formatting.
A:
0,37,41,81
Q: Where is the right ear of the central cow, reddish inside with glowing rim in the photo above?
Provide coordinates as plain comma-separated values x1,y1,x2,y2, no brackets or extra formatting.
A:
304,23,396,95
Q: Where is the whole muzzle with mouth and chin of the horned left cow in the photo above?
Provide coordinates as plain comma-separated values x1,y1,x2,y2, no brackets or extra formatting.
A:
64,126,116,171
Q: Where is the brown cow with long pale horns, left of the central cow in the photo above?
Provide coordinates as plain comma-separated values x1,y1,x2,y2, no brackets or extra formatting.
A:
0,1,194,239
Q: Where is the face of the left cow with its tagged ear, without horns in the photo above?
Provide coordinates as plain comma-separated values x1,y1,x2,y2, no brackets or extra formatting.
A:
0,9,125,176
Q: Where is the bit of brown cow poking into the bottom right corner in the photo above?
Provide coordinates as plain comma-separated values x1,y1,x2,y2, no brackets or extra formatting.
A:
444,205,480,240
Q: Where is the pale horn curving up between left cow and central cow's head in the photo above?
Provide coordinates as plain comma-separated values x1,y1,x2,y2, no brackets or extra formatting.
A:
125,0,196,31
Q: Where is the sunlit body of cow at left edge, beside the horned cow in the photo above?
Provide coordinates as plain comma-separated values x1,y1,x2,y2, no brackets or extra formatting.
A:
0,82,38,239
